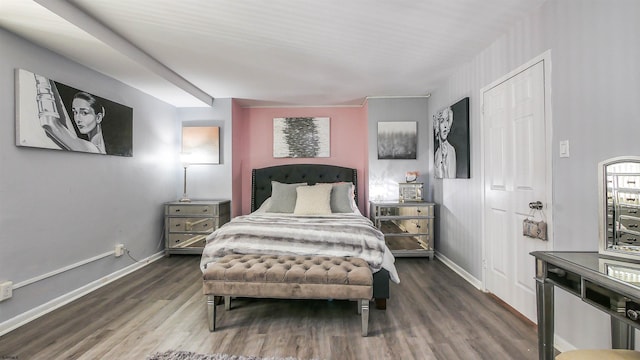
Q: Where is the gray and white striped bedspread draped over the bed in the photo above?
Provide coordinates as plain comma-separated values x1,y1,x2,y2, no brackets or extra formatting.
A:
200,209,400,283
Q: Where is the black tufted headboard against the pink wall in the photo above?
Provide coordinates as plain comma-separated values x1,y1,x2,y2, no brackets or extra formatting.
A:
251,164,358,212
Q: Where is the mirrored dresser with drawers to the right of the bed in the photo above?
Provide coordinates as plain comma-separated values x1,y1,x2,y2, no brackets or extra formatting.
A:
369,201,435,260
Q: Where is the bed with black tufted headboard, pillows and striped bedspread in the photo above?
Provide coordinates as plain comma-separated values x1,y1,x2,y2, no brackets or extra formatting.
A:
201,164,399,309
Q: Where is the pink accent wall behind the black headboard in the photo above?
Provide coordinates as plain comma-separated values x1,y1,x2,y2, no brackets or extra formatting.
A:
232,106,368,216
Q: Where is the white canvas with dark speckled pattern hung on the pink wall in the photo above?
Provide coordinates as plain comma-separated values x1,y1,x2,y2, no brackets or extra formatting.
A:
273,117,331,158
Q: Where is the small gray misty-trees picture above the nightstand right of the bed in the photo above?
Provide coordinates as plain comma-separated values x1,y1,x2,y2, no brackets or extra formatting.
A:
378,121,418,159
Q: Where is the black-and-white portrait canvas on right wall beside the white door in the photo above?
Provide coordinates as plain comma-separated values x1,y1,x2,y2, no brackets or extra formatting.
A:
433,97,471,179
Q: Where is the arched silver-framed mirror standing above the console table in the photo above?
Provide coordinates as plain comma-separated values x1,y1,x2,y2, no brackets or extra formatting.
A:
598,156,640,260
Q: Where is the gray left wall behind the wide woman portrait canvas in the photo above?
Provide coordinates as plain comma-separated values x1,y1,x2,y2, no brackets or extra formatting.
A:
0,29,179,327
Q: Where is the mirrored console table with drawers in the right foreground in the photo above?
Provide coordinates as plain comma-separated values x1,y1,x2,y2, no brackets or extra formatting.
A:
531,251,640,360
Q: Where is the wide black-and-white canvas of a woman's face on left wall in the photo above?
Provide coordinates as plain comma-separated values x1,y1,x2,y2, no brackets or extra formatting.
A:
16,69,133,156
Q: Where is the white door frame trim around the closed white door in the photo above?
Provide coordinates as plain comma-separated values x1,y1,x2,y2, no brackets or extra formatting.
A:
480,49,554,292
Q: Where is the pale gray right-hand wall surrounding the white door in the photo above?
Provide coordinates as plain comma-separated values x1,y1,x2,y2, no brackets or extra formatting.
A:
429,0,640,348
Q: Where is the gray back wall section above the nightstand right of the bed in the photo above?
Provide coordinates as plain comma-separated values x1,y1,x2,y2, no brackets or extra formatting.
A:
366,97,432,208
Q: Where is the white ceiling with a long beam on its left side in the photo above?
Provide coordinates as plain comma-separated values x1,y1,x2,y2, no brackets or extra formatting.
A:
0,0,544,106
